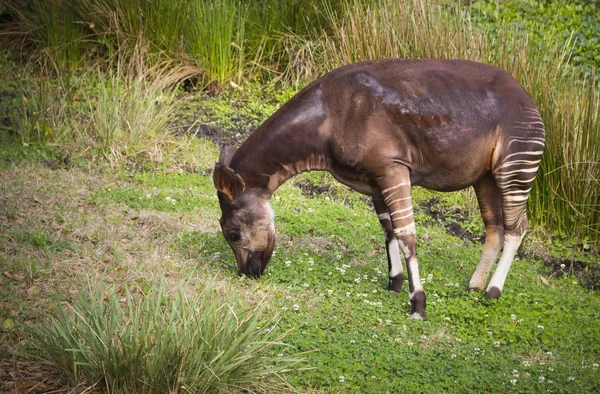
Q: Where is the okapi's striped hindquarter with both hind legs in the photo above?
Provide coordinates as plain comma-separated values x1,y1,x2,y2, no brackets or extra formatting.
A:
469,108,544,299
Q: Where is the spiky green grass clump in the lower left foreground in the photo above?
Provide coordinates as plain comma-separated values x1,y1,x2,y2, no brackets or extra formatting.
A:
32,283,299,393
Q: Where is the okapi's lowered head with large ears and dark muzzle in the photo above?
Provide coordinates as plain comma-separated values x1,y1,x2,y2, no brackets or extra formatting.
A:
213,147,275,278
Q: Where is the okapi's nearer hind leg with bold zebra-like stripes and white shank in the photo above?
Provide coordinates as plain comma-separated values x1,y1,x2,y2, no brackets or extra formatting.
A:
485,108,544,299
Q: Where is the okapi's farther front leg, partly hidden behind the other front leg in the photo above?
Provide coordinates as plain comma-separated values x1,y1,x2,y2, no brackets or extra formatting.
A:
373,197,404,293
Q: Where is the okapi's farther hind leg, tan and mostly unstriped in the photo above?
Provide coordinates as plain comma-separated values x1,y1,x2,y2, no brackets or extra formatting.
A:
469,175,504,291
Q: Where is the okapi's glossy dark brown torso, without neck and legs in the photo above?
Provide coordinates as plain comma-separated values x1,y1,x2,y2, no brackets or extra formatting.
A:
320,59,535,190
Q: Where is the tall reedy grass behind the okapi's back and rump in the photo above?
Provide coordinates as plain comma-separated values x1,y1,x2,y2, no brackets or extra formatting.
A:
321,0,600,248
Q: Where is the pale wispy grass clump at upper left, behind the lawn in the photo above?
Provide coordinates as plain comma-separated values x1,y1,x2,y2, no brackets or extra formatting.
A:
13,49,180,163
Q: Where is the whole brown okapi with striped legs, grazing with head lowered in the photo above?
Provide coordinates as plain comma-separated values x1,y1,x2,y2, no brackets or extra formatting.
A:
213,59,544,319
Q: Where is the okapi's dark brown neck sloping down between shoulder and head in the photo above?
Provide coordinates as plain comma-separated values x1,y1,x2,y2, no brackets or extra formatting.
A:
230,86,330,198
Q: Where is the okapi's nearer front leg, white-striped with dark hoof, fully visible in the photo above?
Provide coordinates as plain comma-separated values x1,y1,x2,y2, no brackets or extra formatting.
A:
378,166,425,319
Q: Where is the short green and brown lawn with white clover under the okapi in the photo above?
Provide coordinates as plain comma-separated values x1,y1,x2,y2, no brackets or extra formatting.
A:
0,89,600,393
